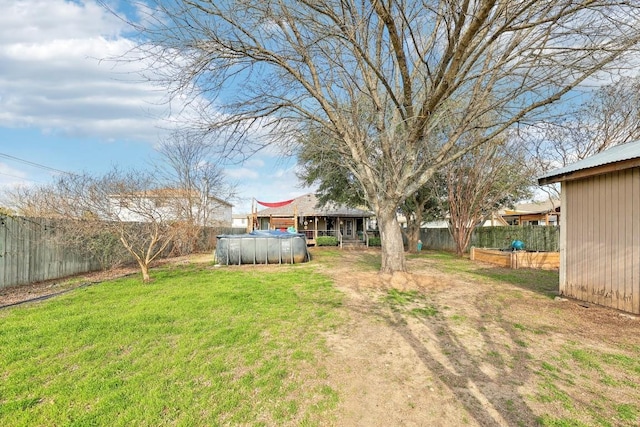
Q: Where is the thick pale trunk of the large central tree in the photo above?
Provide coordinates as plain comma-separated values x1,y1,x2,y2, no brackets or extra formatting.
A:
376,209,407,274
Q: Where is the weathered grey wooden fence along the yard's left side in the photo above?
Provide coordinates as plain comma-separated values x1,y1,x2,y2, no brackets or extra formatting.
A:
0,215,234,289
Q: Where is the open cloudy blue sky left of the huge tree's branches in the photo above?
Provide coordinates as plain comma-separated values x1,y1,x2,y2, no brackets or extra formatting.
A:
0,0,312,214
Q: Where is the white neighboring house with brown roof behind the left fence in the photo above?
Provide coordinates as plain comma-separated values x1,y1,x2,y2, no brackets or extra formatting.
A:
110,188,233,227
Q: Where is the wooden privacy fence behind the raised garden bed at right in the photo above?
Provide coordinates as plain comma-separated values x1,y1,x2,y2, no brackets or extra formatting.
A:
420,225,560,252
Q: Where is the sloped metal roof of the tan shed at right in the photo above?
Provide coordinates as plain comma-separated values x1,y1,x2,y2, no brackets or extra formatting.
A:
538,141,640,185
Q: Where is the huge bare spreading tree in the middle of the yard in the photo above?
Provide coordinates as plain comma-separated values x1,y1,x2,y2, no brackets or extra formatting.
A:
119,0,640,272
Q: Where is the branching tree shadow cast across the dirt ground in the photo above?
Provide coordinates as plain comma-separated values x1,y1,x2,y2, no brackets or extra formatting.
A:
381,292,539,426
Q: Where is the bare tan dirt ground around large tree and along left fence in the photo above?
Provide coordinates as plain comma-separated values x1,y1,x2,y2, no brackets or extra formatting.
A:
0,251,640,426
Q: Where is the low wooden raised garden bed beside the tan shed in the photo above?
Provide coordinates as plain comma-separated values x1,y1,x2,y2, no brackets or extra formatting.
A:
471,247,560,270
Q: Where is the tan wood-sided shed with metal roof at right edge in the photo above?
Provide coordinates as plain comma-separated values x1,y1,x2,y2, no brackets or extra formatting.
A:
538,141,640,314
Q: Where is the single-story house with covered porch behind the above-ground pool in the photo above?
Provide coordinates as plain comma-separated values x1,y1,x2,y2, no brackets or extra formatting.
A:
253,193,373,245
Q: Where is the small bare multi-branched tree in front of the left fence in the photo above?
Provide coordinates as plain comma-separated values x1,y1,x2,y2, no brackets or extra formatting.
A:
7,169,180,282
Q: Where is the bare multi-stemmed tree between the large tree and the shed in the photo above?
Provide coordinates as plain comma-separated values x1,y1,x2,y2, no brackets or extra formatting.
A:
443,141,534,256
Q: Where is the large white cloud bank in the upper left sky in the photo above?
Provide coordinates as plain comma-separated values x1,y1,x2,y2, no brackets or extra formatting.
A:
0,0,168,141
